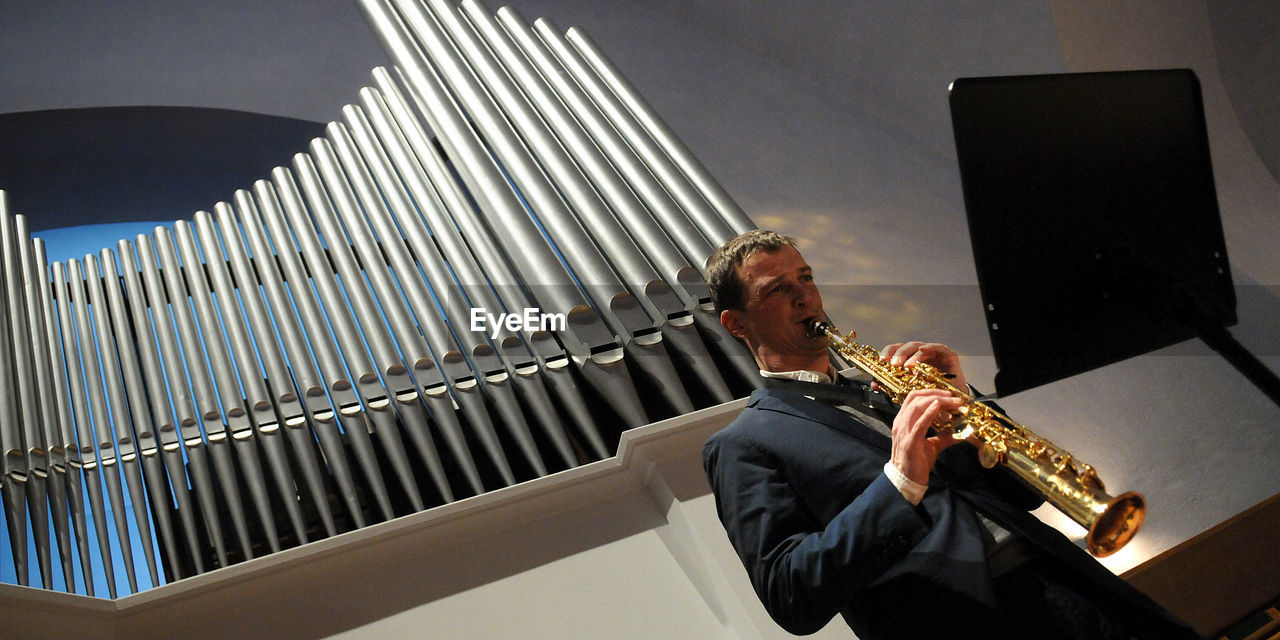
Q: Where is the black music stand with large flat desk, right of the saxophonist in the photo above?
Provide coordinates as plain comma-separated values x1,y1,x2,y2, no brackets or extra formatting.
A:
950,69,1280,403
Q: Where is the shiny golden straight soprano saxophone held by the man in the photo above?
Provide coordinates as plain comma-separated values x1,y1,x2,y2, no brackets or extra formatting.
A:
809,321,1147,558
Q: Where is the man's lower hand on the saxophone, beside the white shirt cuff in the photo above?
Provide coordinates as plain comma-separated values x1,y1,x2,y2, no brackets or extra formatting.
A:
890,389,963,484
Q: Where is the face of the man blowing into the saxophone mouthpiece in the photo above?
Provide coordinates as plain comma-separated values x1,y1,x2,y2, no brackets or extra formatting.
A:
721,246,828,371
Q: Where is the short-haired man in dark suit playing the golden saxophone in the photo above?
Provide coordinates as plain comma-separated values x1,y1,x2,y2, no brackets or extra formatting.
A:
703,230,1199,640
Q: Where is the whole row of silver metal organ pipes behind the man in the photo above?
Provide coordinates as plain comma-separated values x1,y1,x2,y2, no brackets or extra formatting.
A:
0,0,758,598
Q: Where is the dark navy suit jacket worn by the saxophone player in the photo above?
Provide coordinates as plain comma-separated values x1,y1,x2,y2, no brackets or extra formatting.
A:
703,388,1192,640
